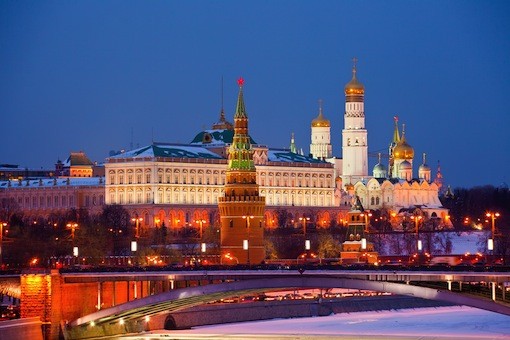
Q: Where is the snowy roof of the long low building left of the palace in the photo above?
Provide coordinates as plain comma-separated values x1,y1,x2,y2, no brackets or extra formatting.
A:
0,177,104,189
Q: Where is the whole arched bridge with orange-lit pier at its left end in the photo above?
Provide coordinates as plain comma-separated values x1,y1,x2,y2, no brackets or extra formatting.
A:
3,270,510,339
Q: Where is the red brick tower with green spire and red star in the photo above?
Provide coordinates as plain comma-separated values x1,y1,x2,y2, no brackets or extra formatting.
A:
218,78,266,264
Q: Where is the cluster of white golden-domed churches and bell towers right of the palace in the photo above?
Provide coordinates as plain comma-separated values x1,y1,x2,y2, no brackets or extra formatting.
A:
310,59,451,226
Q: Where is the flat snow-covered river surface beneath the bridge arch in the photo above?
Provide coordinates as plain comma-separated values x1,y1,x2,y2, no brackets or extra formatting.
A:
137,306,510,339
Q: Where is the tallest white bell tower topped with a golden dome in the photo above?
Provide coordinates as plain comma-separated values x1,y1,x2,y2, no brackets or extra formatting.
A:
342,58,368,186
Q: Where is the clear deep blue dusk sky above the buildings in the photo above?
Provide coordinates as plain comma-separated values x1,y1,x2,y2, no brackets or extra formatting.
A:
0,0,510,187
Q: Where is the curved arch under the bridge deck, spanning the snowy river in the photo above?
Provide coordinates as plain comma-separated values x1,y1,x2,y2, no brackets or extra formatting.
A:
65,273,510,338
